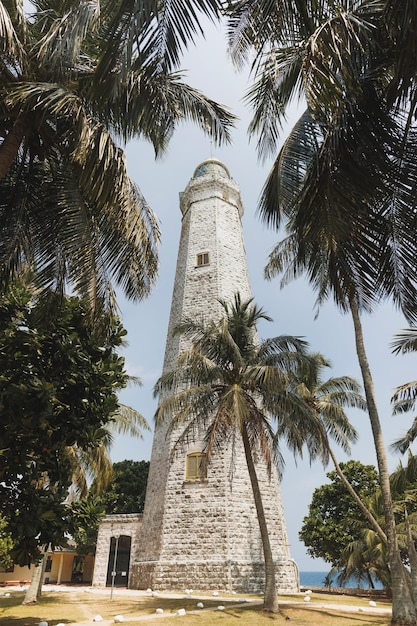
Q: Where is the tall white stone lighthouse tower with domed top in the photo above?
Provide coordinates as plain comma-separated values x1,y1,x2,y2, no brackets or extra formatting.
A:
129,159,298,592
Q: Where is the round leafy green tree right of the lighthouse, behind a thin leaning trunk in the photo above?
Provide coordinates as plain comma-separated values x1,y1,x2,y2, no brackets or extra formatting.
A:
299,461,379,569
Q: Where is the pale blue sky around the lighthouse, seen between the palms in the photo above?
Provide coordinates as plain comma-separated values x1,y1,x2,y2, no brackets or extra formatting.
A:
112,22,417,570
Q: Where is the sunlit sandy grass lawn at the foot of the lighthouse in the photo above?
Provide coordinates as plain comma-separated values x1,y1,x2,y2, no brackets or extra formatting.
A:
0,589,391,626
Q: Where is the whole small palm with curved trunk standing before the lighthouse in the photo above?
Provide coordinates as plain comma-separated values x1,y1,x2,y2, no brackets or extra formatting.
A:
154,294,352,612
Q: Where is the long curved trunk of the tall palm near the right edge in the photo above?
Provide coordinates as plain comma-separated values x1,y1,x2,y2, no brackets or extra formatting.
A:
350,299,416,626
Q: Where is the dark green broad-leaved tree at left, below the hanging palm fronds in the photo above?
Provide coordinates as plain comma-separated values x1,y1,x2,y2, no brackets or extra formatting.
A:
0,283,143,564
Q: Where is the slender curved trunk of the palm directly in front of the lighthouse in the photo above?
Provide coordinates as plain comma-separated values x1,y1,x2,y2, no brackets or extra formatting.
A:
242,424,279,613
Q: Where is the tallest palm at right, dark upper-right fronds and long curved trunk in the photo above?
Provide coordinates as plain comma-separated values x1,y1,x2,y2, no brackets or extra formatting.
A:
229,0,417,624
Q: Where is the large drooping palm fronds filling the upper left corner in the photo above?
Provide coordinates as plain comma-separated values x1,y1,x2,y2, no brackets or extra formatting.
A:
0,0,234,306
